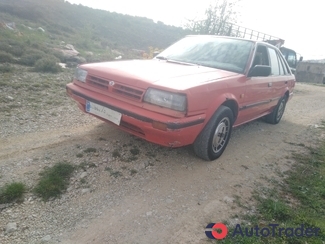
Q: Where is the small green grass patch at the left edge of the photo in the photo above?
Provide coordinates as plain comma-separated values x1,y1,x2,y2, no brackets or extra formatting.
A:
0,182,26,204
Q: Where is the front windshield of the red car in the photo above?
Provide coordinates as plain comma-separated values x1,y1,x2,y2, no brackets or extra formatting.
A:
156,36,253,73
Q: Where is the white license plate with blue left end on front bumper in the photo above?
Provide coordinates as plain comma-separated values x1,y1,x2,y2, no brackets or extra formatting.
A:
86,101,122,125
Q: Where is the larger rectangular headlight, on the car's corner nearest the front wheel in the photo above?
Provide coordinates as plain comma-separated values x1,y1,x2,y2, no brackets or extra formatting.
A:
144,88,186,112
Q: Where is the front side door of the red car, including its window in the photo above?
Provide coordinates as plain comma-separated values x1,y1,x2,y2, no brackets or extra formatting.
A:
237,44,272,124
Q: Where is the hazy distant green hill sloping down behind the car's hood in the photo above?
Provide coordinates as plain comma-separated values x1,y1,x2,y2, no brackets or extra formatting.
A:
0,0,188,49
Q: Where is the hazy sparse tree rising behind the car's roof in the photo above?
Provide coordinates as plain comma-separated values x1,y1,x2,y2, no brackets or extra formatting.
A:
185,0,240,36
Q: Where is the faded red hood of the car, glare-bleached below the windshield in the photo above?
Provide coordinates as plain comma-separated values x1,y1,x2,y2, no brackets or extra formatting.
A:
80,59,238,90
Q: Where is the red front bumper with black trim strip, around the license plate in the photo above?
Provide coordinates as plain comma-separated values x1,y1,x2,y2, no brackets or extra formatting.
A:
66,83,205,147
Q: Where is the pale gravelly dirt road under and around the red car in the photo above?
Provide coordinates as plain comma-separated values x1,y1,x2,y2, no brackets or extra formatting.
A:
0,84,325,244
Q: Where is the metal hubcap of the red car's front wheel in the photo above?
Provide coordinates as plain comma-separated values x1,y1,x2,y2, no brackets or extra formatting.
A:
212,118,230,153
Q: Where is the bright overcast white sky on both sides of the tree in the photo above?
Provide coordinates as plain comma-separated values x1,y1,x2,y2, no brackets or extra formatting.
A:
67,0,325,59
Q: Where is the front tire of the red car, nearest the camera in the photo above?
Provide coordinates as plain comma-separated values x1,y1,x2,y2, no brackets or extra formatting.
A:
193,106,234,161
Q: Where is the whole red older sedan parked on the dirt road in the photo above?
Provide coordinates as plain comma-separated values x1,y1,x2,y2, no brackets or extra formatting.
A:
66,36,295,160
